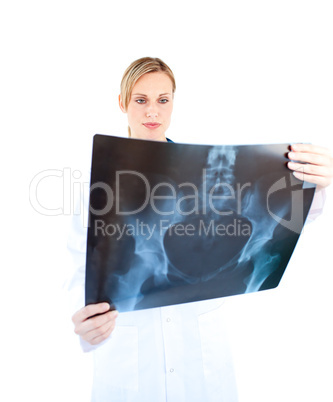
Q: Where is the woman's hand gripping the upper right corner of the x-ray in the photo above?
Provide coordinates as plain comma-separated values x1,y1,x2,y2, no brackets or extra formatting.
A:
288,144,333,187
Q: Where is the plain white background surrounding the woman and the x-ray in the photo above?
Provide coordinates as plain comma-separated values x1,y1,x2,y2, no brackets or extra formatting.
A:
0,0,333,402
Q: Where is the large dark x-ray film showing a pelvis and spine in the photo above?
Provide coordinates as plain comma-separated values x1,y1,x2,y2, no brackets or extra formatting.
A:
86,134,315,312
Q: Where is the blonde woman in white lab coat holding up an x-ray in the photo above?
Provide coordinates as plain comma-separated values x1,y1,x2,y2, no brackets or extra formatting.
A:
73,57,333,402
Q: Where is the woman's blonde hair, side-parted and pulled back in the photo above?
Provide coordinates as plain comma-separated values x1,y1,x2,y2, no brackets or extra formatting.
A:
120,57,176,137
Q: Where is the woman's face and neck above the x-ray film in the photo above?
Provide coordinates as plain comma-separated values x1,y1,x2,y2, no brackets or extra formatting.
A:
119,72,173,141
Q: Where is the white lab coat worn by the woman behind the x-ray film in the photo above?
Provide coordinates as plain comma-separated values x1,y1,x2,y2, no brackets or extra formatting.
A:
68,168,324,402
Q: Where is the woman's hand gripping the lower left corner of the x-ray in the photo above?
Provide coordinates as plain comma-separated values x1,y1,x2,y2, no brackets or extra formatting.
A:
72,303,118,345
